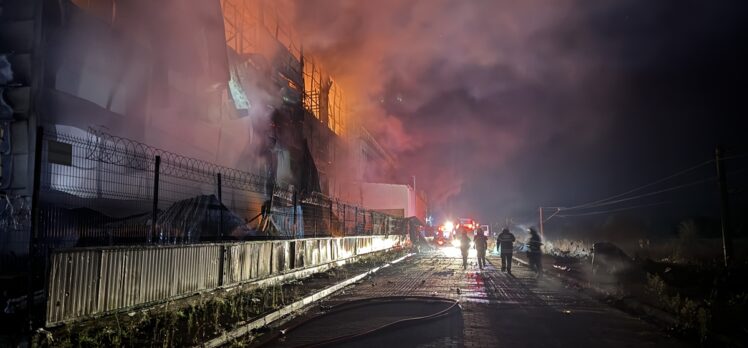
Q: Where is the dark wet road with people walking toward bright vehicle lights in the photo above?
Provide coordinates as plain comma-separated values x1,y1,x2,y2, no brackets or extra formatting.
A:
258,248,685,348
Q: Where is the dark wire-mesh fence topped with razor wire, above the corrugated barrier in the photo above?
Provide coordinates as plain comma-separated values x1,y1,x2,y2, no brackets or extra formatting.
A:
38,130,402,248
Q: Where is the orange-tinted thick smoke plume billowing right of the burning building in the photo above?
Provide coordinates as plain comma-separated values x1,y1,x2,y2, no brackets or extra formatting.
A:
294,0,614,218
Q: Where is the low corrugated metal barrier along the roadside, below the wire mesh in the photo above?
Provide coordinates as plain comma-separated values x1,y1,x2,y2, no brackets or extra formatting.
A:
46,235,405,326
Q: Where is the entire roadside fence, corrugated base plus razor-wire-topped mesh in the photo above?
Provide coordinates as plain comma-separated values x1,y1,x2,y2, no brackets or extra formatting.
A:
30,130,406,325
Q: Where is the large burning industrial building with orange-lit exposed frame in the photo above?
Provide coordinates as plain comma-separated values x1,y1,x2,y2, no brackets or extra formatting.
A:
0,0,414,264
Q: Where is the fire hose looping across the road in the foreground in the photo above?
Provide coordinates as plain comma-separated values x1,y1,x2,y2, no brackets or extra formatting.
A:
259,296,461,348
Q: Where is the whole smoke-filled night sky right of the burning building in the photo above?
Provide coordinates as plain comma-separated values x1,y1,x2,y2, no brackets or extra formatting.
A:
295,0,748,232
